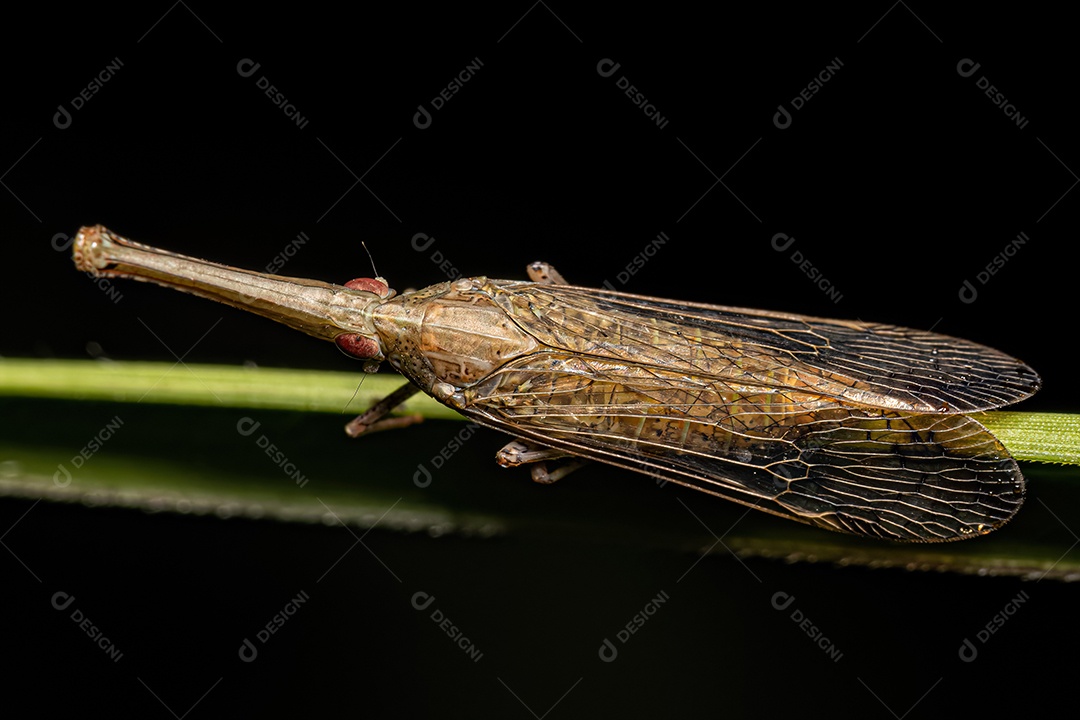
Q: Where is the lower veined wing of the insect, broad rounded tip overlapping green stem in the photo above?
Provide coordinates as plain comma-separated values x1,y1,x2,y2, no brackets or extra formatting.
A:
463,352,1024,542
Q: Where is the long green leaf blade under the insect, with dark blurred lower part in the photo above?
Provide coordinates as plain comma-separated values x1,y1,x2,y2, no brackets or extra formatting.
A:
0,359,1080,580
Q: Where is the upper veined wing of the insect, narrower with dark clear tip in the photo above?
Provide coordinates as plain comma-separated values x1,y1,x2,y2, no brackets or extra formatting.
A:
486,281,1040,413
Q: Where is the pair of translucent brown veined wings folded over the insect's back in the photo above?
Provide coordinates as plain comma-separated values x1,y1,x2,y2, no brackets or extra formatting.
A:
457,283,1038,542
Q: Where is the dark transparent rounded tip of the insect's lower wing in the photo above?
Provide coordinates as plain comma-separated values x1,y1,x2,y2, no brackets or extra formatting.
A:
777,416,1026,543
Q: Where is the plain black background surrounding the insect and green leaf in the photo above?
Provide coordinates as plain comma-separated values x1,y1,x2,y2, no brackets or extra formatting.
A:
0,3,1080,718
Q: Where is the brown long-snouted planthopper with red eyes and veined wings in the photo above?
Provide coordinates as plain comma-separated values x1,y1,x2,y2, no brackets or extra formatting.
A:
73,226,1040,542
